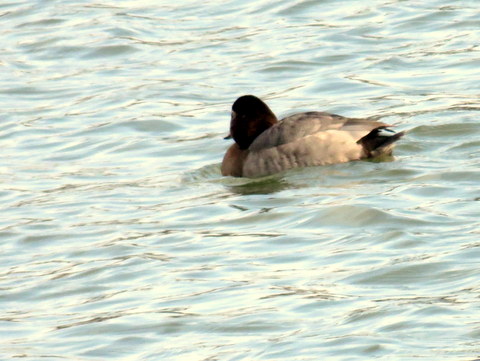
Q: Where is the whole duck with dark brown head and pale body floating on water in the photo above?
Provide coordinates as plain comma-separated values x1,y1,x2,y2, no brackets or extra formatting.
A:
221,95,404,178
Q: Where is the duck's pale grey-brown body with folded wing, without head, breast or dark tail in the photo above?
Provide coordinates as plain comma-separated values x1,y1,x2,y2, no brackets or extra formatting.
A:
243,112,386,177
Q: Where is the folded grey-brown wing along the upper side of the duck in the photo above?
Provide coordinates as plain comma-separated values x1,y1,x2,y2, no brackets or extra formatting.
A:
249,112,387,152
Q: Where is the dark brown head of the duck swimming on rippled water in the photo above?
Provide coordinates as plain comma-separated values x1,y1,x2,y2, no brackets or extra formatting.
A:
230,95,277,149
